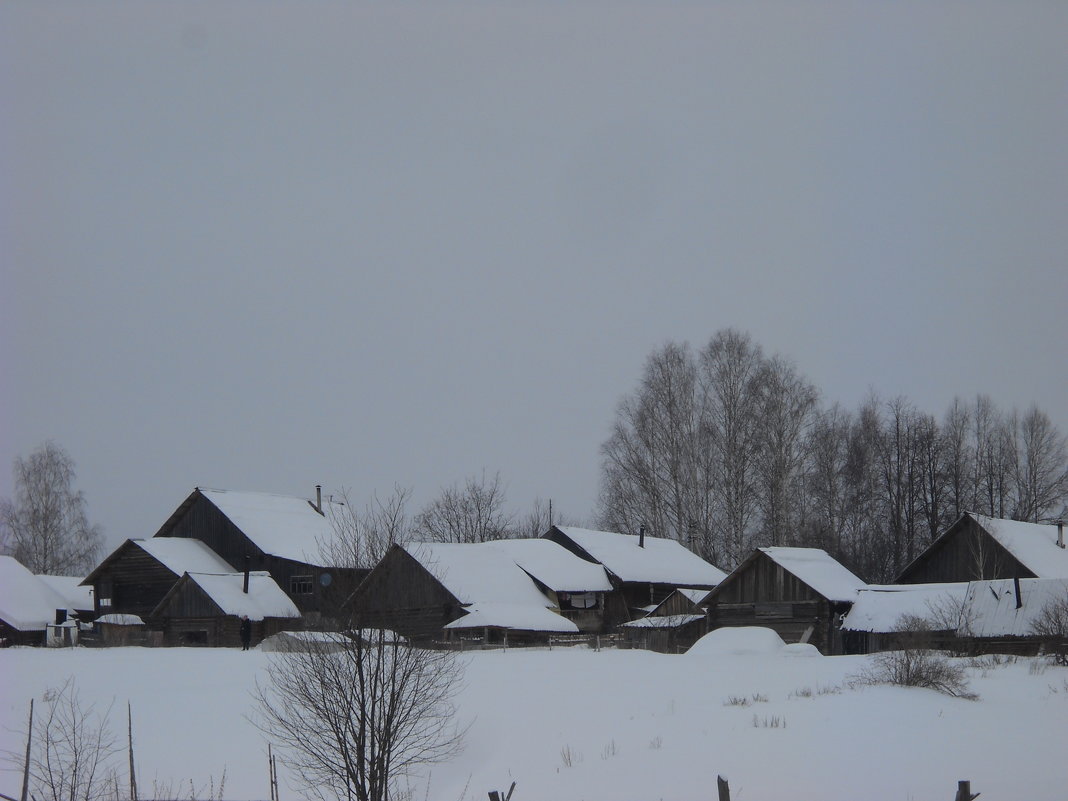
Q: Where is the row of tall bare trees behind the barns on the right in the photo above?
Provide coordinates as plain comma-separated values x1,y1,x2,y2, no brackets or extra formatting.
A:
599,329,1068,581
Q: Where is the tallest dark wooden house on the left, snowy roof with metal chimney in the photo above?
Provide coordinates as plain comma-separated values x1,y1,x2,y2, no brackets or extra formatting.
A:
154,487,368,624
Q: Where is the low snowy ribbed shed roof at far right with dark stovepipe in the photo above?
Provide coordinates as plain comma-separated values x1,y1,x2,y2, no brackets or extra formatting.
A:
957,578,1068,637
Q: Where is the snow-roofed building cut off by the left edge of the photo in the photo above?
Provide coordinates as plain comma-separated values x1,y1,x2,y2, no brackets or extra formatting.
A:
0,556,73,646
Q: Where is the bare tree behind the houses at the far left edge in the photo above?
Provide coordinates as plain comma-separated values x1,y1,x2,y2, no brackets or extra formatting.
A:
0,442,104,576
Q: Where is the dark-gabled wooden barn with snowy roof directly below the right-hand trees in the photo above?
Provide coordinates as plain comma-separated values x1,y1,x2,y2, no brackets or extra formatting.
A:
897,513,1068,584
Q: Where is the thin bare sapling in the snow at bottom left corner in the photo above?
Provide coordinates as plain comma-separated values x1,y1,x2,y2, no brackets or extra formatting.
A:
24,678,122,801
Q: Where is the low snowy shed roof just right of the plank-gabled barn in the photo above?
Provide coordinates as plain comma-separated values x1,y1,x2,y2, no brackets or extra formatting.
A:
842,582,968,633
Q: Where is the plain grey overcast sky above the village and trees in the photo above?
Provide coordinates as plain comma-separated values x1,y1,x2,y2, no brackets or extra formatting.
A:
0,2,1068,548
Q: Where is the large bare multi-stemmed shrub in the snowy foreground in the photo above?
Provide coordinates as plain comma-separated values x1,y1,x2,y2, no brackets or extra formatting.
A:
254,629,464,801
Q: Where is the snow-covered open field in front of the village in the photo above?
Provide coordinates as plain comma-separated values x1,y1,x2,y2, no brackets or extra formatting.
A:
0,647,1068,801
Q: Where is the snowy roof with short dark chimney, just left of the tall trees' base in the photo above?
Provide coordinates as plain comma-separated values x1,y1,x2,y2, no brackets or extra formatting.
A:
555,525,726,587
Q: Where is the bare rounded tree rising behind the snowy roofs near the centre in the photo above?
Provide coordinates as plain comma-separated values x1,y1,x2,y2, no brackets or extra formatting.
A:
412,473,515,543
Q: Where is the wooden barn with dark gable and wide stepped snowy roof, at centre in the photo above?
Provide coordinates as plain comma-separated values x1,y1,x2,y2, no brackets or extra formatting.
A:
350,543,579,644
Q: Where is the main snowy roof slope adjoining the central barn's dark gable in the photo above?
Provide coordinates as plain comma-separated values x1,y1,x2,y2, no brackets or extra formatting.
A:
404,543,552,608
